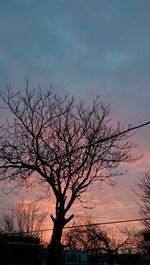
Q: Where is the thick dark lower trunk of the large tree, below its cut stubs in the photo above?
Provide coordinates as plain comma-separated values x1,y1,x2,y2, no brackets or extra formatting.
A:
46,219,64,265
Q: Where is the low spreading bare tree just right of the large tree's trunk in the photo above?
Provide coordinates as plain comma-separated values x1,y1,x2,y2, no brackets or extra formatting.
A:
64,218,133,265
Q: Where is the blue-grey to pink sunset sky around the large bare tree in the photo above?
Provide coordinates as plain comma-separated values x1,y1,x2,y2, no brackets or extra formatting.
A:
0,0,150,235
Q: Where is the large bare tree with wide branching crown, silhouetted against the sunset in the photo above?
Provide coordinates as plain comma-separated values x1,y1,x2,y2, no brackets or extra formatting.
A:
0,82,136,264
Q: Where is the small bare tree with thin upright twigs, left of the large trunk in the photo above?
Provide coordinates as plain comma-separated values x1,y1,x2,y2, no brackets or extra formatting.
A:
0,201,47,241
